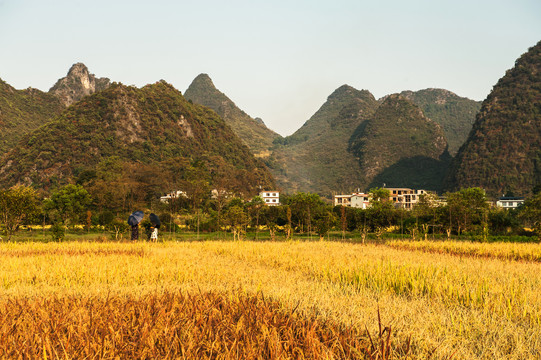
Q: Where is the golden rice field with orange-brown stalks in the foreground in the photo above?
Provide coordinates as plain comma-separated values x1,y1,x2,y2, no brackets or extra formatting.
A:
0,241,541,359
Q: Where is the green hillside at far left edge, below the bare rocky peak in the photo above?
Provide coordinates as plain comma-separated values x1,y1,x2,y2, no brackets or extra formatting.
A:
0,79,64,158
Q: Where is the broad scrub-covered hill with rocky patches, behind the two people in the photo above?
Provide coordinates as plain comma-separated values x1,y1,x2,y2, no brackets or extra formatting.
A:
0,82,274,194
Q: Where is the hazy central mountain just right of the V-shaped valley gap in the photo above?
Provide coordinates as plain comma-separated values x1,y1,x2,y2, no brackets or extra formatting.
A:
267,85,378,196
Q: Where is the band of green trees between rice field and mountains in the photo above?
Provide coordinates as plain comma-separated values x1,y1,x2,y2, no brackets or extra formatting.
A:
0,181,541,241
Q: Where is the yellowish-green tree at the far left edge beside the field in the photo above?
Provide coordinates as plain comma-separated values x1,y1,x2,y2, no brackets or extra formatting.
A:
0,186,38,240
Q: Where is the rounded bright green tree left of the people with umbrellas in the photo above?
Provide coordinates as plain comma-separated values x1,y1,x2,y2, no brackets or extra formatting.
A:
45,184,92,224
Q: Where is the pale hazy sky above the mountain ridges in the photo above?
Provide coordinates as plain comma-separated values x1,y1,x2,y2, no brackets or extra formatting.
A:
0,0,541,136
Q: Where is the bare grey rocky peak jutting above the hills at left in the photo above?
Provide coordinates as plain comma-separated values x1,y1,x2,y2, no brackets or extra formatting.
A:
49,63,111,106
